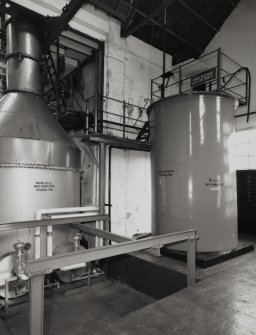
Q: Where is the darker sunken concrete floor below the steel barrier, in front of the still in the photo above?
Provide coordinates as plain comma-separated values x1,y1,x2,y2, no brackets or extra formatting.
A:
0,277,155,335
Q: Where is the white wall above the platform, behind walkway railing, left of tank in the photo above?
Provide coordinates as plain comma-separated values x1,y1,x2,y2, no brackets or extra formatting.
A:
104,19,172,139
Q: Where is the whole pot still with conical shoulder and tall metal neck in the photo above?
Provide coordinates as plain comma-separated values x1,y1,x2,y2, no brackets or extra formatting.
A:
0,16,80,256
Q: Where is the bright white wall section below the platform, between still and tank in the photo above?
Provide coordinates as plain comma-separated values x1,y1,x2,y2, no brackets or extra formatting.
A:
111,149,151,237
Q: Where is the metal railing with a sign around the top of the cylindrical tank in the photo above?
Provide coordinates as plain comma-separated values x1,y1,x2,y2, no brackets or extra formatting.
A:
151,48,250,111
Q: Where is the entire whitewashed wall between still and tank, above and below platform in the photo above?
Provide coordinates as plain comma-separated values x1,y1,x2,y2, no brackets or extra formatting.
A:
15,0,172,236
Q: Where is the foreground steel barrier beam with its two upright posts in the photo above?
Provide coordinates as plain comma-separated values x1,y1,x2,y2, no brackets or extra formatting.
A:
26,225,197,335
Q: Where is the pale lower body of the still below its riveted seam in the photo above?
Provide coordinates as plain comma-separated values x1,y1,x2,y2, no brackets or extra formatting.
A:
0,166,80,260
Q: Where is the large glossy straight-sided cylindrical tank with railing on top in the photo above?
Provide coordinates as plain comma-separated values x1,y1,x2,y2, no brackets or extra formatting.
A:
148,92,238,252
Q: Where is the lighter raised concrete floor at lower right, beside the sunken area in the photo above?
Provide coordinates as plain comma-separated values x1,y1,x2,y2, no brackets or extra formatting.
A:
100,252,256,335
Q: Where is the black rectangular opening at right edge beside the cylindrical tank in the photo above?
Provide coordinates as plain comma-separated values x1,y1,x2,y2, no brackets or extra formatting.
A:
236,170,256,235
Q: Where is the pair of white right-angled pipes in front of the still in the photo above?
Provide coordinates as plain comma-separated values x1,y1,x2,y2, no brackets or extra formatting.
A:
34,206,99,258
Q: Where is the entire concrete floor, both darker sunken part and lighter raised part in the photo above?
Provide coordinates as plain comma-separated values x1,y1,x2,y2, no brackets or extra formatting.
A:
0,240,256,335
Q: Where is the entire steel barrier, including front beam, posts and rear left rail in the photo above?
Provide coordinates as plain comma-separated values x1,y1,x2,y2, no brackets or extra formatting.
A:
0,215,198,335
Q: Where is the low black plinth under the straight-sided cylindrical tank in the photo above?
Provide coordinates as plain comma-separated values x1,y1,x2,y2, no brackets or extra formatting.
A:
161,242,254,269
